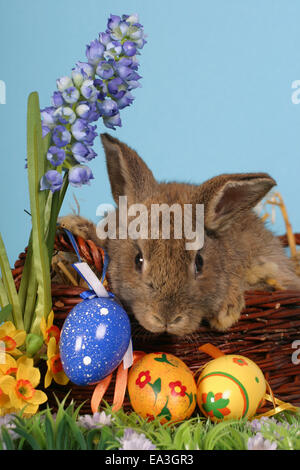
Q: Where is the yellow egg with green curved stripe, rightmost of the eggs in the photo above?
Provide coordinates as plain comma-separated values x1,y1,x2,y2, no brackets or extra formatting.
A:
197,354,266,421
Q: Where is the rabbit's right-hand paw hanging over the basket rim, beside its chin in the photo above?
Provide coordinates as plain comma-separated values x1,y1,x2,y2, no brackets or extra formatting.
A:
209,295,245,331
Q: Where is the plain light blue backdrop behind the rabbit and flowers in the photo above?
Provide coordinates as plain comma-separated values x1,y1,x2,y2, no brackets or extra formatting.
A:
0,0,300,264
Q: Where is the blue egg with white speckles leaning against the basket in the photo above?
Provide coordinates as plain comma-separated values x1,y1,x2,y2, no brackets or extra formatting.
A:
59,297,131,385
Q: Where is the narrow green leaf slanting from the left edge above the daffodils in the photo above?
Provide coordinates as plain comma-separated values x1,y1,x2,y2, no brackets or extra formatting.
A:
0,234,24,330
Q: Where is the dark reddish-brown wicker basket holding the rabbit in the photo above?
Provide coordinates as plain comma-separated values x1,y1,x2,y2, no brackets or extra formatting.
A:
13,233,300,413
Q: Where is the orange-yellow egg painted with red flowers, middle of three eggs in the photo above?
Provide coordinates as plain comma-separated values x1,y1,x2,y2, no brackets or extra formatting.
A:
128,352,197,423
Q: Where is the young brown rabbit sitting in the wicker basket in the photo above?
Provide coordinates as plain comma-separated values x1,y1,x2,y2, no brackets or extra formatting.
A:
61,134,300,335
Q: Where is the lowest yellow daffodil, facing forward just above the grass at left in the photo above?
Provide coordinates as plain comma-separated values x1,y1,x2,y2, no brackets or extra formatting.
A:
0,356,47,415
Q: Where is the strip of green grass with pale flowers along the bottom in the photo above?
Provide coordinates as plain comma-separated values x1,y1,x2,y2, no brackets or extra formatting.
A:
0,394,300,451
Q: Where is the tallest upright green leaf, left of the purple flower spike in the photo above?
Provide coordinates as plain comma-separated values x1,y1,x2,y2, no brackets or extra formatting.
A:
27,92,52,334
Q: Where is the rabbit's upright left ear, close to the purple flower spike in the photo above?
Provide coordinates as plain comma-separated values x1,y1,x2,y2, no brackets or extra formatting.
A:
101,134,157,204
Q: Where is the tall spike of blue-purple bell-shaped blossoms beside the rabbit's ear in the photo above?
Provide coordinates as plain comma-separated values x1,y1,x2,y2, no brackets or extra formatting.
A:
41,14,145,192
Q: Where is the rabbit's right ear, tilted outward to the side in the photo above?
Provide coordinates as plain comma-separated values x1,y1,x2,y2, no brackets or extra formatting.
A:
200,173,276,230
